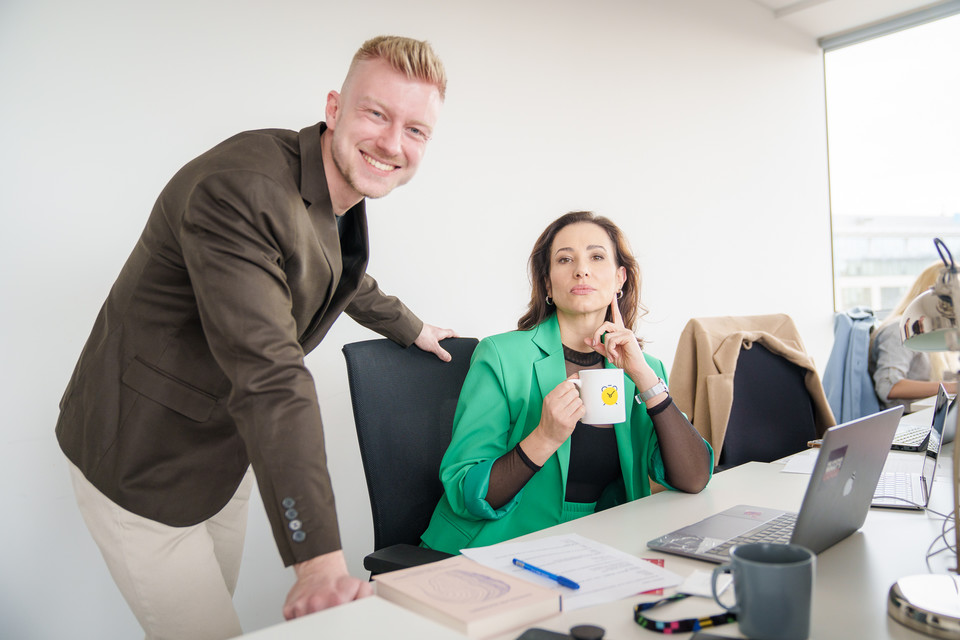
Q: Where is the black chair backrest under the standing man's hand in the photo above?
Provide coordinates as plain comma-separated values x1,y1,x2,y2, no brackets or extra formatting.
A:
343,338,477,549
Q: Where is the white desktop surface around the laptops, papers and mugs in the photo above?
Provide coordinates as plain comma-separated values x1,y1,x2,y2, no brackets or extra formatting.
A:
238,445,953,640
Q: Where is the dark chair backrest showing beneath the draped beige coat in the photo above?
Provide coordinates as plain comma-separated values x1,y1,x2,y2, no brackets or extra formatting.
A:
718,342,817,469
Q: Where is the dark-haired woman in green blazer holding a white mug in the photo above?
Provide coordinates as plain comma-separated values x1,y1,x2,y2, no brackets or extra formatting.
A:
422,212,713,553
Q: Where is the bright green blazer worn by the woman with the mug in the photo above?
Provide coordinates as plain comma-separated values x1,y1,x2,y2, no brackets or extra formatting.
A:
421,315,700,553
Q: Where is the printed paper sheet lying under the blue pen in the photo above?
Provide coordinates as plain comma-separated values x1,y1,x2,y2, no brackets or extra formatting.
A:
461,534,683,611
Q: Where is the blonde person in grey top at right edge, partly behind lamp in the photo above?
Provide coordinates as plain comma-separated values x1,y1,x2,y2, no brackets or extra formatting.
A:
868,262,957,411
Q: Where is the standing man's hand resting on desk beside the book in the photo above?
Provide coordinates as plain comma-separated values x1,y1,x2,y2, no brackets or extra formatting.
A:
283,551,373,620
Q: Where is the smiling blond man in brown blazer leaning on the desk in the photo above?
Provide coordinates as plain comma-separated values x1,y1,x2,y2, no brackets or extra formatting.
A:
57,37,455,640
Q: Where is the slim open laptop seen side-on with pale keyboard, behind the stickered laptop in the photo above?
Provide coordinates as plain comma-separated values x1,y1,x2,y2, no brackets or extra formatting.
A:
871,385,949,509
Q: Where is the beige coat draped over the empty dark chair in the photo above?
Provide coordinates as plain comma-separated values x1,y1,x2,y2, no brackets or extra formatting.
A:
670,313,836,460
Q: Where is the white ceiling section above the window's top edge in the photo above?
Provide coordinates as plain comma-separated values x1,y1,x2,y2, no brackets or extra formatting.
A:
753,0,945,39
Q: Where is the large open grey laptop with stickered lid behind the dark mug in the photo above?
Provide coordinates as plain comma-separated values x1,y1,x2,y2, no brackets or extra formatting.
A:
647,406,903,563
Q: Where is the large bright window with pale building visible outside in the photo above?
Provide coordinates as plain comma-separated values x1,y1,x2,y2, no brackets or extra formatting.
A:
821,8,960,318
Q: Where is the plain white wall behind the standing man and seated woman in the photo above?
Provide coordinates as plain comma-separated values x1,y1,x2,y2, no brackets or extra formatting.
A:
0,0,832,639
